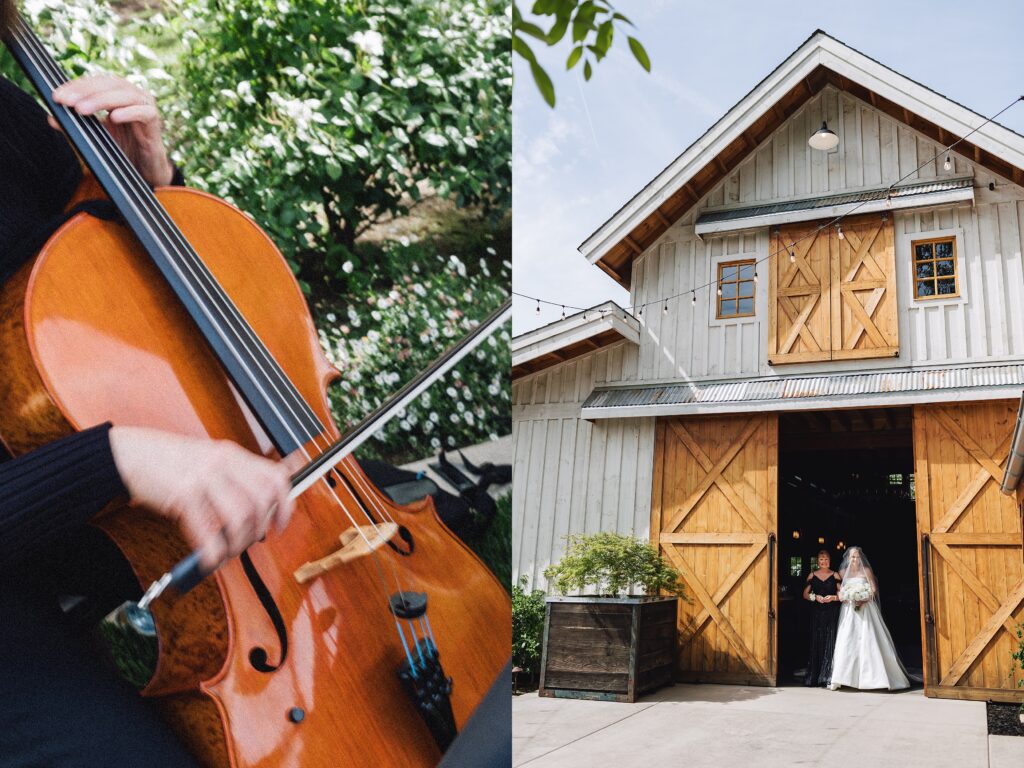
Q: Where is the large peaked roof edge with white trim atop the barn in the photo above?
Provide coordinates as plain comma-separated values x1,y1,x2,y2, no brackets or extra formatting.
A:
580,30,1024,287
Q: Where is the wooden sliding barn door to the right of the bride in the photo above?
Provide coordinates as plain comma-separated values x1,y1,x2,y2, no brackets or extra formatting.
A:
913,400,1024,700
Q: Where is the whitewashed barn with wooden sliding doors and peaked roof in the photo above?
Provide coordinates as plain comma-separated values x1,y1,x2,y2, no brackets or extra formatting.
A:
513,31,1024,699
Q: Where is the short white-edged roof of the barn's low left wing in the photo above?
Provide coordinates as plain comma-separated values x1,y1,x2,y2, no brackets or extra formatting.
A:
512,301,640,379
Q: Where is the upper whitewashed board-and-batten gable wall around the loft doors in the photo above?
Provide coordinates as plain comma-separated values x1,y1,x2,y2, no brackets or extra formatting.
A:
631,86,1024,381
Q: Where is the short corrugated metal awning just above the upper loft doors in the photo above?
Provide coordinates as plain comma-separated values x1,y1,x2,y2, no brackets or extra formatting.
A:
694,176,974,234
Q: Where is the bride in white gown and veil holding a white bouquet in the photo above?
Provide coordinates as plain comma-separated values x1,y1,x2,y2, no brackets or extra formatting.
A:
828,547,910,690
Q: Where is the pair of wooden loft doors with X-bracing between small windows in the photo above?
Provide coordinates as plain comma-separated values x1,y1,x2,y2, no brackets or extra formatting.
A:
768,215,899,366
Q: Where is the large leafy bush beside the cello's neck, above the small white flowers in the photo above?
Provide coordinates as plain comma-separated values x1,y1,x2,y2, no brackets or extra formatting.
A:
175,0,512,289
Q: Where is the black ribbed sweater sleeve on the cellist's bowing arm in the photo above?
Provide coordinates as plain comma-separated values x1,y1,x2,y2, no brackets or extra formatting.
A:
0,424,127,569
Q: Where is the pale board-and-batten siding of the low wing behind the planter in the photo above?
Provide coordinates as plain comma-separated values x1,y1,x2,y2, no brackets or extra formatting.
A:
512,342,654,590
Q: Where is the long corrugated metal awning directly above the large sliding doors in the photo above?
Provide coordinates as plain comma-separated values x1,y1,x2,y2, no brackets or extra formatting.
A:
580,362,1024,419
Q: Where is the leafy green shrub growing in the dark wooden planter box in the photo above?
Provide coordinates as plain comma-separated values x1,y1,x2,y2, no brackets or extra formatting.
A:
544,531,683,596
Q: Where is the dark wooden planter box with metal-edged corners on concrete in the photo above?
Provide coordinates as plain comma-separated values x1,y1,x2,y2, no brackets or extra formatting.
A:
540,597,678,701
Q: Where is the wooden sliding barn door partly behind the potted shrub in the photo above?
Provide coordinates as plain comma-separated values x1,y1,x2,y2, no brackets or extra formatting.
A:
651,414,778,685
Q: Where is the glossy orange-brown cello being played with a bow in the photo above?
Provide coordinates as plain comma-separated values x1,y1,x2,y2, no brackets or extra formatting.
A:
0,15,511,768
